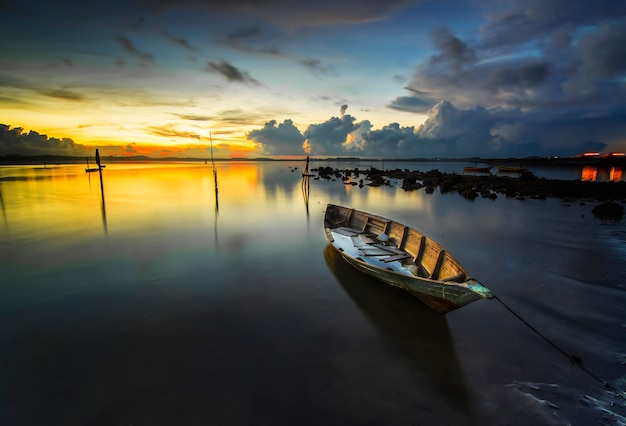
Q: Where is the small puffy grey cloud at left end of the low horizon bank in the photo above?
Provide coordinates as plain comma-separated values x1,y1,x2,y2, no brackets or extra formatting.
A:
248,120,305,155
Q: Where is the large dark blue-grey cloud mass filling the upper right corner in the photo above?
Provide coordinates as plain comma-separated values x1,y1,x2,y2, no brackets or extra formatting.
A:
408,0,626,115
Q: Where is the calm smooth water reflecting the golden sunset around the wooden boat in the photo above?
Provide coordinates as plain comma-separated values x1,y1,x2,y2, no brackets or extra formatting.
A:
0,162,626,425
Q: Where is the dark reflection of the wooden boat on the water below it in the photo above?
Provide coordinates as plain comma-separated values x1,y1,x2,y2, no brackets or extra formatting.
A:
324,245,471,420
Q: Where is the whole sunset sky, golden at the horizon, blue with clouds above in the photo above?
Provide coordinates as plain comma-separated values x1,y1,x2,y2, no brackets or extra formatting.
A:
0,0,626,158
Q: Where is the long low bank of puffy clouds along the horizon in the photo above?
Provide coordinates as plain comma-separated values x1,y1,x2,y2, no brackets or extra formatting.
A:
248,101,626,158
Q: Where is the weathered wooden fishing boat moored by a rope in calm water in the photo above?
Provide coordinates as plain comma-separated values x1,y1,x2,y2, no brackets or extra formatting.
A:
324,204,494,314
